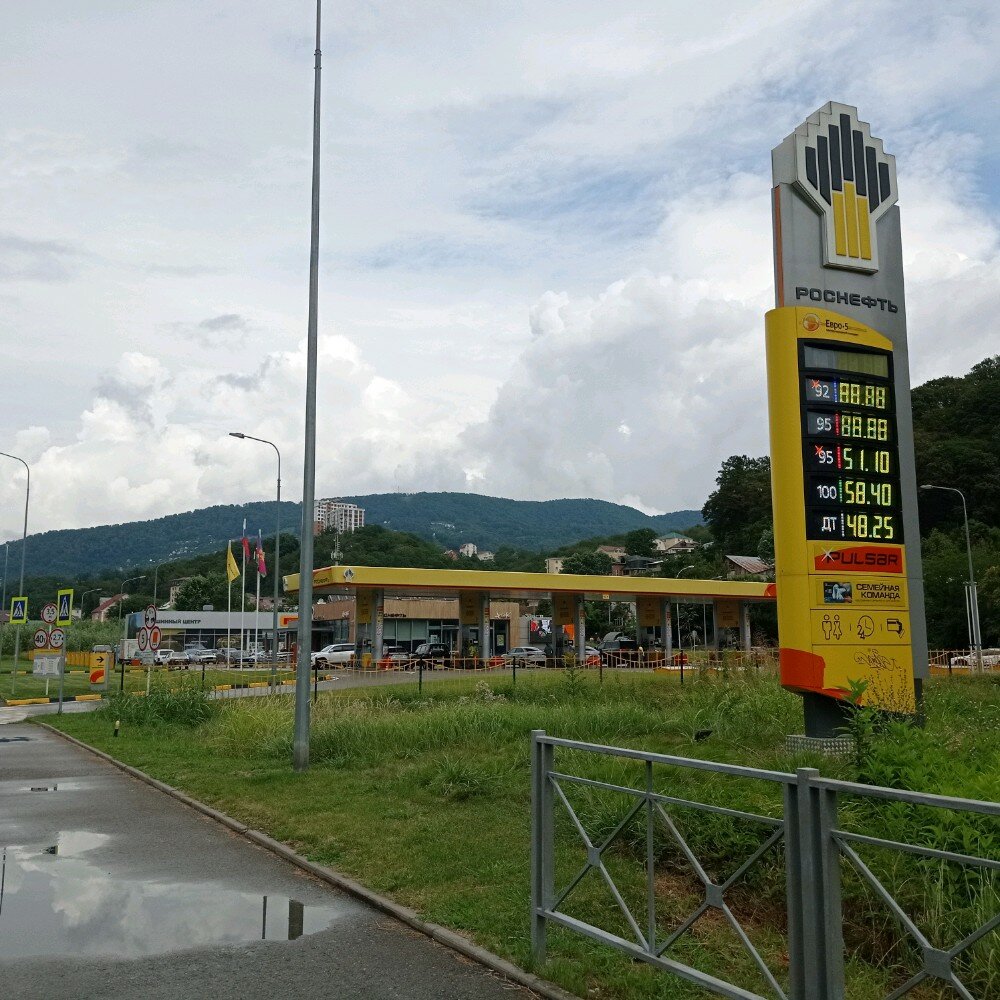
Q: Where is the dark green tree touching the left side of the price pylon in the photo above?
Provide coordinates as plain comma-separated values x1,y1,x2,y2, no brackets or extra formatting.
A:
701,455,772,555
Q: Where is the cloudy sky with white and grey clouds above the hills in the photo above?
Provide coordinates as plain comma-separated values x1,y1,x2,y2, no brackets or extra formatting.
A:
0,0,1000,540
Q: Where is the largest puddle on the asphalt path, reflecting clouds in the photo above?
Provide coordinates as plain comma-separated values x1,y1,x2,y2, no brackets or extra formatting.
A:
0,831,360,961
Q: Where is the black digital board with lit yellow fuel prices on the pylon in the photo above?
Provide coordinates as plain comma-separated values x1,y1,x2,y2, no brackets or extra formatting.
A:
799,340,903,543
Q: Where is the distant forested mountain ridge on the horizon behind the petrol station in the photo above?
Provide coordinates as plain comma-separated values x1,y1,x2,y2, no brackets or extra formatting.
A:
1,493,701,580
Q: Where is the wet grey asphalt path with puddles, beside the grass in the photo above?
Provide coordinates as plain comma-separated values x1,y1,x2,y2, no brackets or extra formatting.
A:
0,723,532,1000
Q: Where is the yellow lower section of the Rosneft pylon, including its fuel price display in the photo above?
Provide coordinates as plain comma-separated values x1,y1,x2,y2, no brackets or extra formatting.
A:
767,308,913,711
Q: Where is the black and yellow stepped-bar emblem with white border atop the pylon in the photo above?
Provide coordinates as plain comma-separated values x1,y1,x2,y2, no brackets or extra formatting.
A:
795,103,897,274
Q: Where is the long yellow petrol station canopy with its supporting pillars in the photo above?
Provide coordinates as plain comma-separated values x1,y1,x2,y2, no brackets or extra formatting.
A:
284,566,775,662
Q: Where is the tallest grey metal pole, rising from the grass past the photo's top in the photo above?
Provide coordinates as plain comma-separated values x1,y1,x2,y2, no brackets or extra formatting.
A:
292,0,322,771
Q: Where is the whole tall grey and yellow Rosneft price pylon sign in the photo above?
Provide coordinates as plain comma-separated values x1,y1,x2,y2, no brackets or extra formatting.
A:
766,102,929,737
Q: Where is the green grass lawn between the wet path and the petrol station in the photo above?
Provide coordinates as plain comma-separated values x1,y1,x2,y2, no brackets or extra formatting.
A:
47,671,1000,1000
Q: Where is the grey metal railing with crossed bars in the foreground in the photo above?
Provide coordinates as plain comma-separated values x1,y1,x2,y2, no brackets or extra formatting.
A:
531,730,1000,1000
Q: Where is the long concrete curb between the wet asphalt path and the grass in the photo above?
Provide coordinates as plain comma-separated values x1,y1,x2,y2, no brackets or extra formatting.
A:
34,722,580,1000
